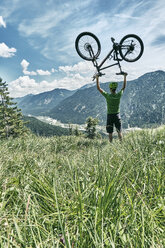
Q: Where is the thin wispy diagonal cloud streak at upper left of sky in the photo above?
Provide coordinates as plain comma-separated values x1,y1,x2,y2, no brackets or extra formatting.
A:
19,0,93,38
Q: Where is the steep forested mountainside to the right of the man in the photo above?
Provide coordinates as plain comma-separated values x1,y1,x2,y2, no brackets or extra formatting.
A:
121,71,165,127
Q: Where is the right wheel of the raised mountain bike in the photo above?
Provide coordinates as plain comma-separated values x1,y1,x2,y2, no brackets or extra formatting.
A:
119,34,144,62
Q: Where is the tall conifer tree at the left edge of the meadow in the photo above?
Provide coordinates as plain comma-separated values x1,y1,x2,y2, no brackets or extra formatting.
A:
0,78,26,138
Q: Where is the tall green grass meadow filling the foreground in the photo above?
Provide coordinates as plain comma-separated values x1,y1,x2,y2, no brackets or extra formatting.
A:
0,127,165,248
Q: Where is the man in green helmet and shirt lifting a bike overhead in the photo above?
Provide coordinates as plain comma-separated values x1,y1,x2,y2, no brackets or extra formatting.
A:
96,73,127,142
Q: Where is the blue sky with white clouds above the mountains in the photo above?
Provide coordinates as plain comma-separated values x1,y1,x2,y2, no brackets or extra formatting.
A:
0,0,165,97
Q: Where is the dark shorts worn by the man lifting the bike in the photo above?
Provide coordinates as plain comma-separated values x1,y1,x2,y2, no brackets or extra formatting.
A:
106,114,121,133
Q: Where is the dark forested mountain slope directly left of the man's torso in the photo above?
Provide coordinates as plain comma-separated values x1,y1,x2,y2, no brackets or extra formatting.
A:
49,85,106,124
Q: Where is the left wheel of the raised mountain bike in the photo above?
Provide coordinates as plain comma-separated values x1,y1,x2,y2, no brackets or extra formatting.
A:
75,32,101,61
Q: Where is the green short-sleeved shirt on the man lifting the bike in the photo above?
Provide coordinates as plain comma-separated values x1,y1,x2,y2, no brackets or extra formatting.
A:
102,90,123,114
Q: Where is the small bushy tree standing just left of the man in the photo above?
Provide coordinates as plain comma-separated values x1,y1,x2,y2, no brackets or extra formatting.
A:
86,117,99,139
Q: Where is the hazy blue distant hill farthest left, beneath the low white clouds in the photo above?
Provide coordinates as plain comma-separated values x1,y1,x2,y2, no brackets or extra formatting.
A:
14,89,75,115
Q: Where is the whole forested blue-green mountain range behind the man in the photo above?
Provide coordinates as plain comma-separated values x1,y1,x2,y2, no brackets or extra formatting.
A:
15,70,165,128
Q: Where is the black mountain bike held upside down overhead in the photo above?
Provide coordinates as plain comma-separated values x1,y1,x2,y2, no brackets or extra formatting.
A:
75,32,144,80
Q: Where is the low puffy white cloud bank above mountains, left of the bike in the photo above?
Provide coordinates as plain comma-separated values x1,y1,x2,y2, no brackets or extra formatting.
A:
9,60,93,97
